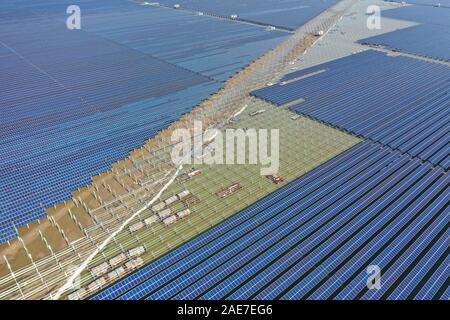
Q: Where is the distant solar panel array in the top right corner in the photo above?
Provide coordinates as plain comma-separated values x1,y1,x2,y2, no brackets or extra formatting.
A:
359,5,450,61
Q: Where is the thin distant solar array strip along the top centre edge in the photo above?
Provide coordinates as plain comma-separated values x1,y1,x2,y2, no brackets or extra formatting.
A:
159,0,337,30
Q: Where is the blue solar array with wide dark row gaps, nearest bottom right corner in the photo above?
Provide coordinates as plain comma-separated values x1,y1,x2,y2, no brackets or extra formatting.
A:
93,141,450,299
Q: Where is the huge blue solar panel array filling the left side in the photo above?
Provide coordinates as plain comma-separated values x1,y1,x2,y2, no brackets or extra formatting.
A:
0,0,287,242
